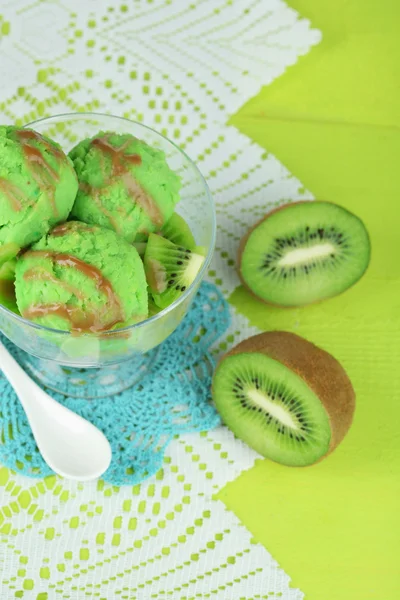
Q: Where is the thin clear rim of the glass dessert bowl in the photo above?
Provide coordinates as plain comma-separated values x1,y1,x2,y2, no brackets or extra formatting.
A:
0,112,217,338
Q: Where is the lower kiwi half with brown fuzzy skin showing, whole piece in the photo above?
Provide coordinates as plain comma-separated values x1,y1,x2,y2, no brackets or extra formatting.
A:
213,331,355,466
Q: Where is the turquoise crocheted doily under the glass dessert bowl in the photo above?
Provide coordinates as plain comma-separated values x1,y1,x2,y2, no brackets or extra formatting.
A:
0,283,229,485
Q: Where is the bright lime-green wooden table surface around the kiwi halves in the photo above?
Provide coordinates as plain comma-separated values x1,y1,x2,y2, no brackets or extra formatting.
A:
220,0,400,600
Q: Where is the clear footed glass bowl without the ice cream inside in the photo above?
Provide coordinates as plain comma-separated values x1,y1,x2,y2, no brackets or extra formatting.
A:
0,113,216,399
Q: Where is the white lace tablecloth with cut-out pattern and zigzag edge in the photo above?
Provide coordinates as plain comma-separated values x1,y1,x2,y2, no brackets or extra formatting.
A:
0,0,320,600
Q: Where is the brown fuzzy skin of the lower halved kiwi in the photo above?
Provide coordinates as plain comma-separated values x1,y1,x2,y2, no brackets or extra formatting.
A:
217,331,355,462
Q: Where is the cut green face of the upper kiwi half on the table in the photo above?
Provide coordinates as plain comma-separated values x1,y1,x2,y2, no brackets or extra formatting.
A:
239,201,370,306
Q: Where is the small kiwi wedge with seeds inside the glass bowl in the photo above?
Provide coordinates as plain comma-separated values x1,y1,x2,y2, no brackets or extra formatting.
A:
143,233,204,308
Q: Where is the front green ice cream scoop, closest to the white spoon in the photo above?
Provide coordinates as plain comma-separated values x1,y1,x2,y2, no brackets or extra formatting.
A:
15,221,148,332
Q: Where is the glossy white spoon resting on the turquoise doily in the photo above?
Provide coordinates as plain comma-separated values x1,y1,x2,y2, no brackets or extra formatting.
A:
0,342,111,481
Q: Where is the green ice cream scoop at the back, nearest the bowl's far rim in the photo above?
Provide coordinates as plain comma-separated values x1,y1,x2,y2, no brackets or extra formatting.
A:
69,132,181,242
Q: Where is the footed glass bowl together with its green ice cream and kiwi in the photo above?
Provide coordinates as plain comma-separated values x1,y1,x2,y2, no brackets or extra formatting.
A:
0,113,216,399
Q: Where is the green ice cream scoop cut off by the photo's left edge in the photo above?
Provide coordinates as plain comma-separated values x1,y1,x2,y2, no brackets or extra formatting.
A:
0,126,78,262
